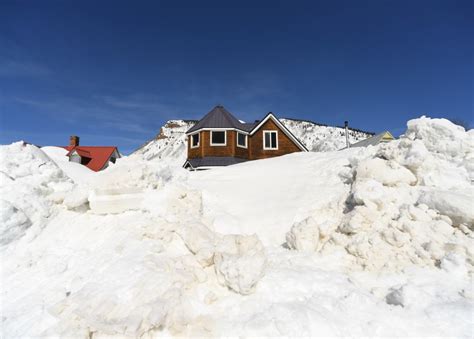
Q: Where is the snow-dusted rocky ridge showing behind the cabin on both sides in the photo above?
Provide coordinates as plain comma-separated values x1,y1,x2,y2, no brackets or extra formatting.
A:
131,118,374,163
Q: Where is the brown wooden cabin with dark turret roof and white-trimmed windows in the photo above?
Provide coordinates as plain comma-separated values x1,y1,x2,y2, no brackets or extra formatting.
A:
183,106,308,170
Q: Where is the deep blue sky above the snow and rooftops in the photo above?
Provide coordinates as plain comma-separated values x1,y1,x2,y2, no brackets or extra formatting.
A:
0,0,474,153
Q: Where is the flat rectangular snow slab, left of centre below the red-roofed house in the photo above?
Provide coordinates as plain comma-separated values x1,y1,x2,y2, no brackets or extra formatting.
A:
89,187,143,214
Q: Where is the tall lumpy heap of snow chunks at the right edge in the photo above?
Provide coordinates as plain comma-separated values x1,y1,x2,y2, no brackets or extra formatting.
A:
334,117,474,270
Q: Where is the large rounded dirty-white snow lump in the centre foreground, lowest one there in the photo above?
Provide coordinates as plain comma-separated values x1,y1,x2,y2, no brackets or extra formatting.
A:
214,234,267,295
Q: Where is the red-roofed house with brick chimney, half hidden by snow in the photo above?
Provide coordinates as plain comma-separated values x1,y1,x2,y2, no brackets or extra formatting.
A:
64,135,121,172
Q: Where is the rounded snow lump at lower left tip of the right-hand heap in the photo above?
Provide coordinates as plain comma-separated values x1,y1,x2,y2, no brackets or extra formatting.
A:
286,217,319,251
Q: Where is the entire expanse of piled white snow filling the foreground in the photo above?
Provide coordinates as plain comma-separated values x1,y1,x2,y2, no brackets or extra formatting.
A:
0,118,474,338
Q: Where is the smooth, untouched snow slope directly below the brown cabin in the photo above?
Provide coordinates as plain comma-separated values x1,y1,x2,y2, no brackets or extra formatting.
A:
189,149,357,245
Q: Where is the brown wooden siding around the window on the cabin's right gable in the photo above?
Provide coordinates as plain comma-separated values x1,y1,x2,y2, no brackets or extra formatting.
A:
249,119,300,160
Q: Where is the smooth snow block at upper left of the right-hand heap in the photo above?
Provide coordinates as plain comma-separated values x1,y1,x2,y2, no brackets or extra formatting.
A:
356,158,416,186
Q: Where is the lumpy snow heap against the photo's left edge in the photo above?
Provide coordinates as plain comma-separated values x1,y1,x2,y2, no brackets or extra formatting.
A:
0,141,74,244
